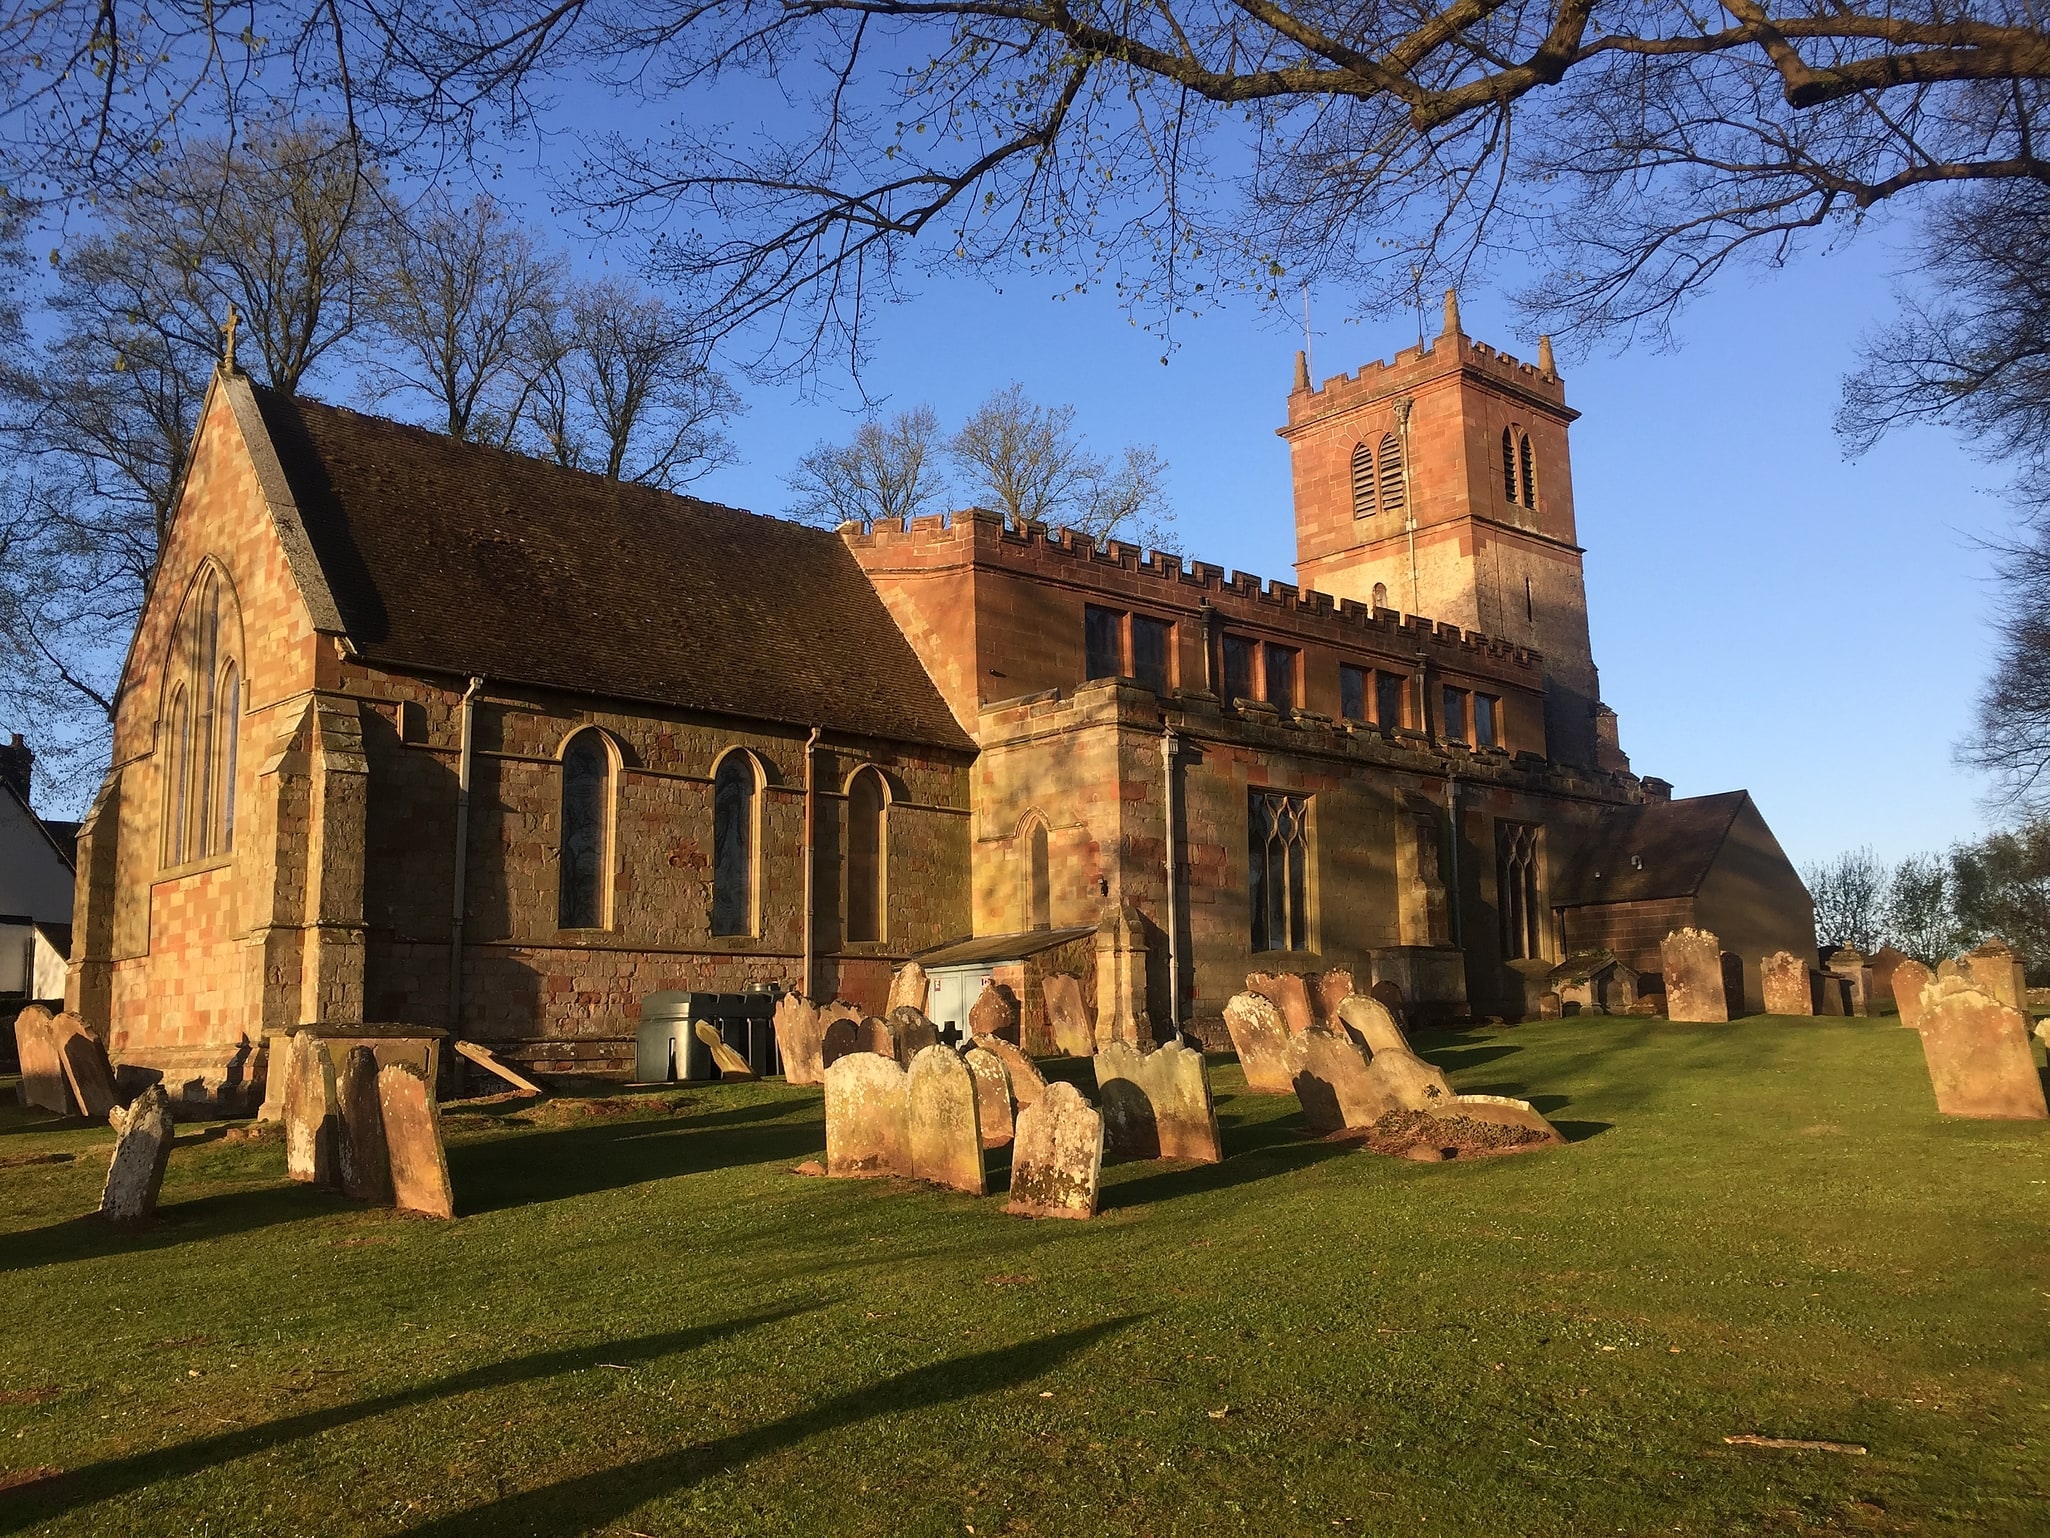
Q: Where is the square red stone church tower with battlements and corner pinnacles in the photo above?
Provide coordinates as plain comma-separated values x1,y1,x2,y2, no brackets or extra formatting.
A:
1281,291,1628,769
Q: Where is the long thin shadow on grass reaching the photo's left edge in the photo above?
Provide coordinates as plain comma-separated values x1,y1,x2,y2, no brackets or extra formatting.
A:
0,1302,824,1532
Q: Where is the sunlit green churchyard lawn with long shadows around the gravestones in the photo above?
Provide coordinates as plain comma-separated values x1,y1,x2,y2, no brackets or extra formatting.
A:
0,1019,2050,1538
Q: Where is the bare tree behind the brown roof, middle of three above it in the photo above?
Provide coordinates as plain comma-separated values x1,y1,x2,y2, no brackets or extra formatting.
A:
363,187,568,445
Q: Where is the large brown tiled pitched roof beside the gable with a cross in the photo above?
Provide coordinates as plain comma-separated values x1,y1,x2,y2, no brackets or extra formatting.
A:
250,386,974,748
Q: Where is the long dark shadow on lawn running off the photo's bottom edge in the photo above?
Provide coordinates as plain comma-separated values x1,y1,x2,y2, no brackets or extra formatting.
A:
391,1317,1136,1538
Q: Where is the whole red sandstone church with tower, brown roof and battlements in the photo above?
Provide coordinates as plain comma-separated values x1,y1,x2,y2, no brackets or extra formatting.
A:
70,306,1814,1097
